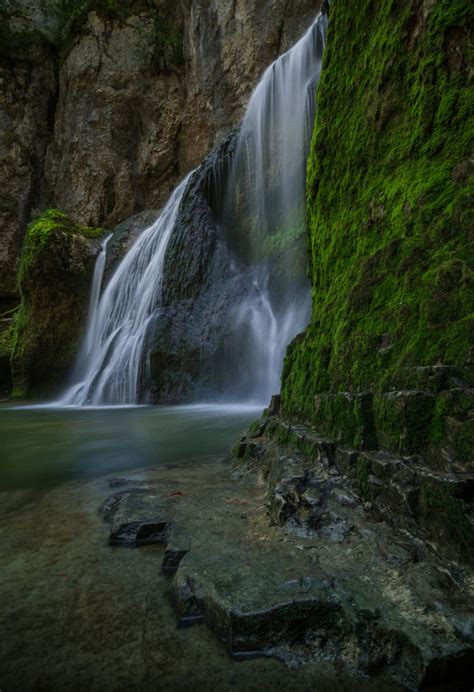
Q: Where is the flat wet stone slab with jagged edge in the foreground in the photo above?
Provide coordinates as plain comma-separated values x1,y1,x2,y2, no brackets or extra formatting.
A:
105,460,474,689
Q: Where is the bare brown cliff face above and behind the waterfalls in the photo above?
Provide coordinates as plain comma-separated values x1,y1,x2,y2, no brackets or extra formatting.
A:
0,0,318,298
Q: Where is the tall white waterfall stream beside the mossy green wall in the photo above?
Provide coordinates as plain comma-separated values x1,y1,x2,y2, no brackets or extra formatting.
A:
221,14,327,402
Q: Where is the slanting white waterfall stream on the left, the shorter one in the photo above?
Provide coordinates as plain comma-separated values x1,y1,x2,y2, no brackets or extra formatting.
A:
59,174,191,406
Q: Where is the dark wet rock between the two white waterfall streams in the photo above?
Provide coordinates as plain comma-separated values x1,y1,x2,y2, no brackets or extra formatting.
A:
144,132,262,403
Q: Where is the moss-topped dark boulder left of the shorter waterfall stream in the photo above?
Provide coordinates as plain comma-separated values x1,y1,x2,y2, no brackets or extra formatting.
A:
12,209,104,398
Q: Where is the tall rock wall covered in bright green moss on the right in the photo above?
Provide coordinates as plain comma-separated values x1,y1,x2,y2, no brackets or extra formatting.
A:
282,0,474,462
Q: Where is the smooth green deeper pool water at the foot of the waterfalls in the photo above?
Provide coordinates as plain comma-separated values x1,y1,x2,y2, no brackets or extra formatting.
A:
0,404,263,491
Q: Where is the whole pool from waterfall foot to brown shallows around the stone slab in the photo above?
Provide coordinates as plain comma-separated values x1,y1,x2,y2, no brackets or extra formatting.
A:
0,404,388,692
